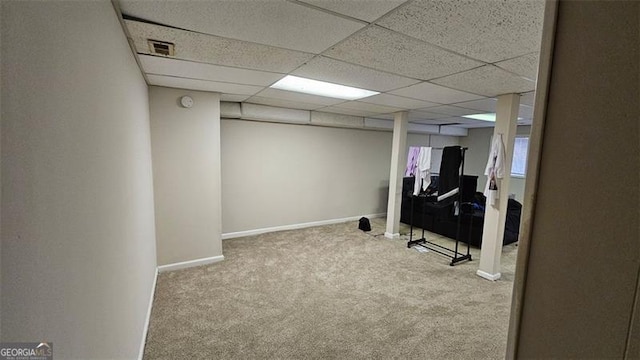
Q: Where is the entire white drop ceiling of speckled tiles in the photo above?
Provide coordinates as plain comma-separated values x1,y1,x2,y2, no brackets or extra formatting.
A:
118,0,544,128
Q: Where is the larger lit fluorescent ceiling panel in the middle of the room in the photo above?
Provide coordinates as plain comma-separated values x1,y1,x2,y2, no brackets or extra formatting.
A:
270,75,380,100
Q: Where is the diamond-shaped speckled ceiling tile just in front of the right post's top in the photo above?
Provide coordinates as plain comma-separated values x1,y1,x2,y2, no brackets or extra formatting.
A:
433,65,536,97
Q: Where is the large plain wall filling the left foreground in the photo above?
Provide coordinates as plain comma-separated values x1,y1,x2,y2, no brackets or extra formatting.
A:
1,1,156,359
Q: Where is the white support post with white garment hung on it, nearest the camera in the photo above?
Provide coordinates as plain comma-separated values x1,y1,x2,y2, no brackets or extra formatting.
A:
477,94,520,281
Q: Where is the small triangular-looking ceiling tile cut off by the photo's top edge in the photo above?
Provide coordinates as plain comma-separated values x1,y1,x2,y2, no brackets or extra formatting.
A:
300,0,406,22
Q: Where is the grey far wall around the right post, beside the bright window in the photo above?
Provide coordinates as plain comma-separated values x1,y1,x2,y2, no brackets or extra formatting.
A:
460,126,531,203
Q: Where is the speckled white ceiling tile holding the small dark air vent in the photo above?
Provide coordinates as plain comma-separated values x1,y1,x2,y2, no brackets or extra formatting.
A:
125,20,313,73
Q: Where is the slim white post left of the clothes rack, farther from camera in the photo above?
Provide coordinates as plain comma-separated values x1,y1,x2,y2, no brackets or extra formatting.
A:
384,111,409,239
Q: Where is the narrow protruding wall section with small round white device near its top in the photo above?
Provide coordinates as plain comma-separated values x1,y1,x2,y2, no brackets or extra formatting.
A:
149,86,222,265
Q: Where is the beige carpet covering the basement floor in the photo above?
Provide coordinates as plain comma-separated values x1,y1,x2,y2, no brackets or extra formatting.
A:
144,219,517,359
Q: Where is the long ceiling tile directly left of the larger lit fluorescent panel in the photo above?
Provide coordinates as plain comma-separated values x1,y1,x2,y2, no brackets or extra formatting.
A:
140,55,284,86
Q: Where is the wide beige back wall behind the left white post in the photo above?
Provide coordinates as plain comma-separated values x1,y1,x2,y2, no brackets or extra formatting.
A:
222,119,391,233
